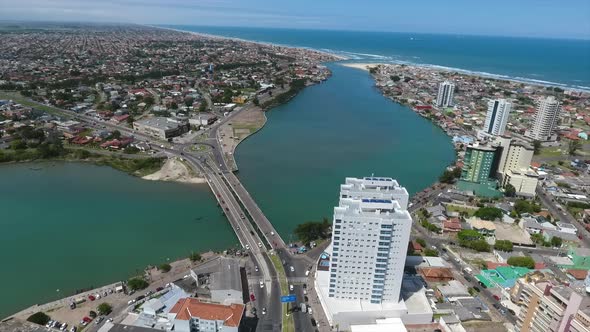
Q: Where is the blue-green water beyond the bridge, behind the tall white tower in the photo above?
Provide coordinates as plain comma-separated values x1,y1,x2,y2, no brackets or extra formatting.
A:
235,65,454,236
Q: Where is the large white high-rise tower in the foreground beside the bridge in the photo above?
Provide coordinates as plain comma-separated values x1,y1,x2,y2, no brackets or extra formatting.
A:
328,177,412,303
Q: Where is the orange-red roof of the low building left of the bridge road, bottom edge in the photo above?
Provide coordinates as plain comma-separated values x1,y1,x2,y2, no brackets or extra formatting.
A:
170,297,244,326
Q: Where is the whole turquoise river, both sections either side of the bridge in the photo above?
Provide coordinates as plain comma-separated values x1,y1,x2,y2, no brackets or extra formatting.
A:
0,64,454,317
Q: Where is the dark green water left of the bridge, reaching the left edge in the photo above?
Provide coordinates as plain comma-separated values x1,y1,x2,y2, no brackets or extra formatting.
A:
0,163,237,318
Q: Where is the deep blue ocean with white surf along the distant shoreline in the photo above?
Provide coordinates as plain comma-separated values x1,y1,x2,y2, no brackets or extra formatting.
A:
168,25,590,90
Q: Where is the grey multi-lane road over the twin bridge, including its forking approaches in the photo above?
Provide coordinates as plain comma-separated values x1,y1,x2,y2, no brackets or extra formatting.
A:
30,98,306,331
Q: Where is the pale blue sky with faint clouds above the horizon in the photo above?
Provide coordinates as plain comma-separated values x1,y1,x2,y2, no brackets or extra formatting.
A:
0,0,590,39
